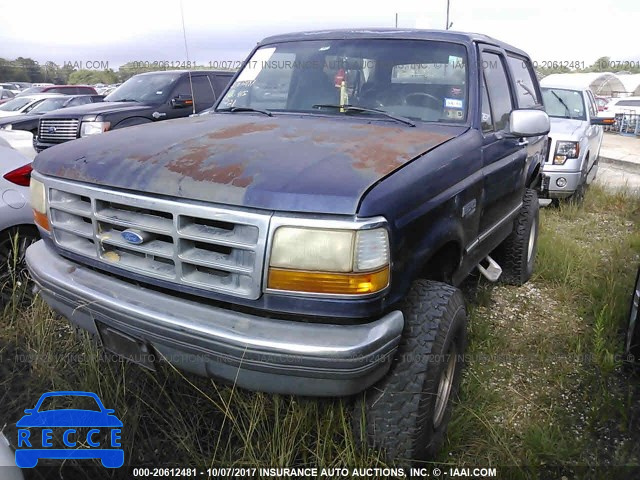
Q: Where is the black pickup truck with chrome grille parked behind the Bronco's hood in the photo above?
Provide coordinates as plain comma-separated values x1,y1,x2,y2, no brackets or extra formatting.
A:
33,70,233,152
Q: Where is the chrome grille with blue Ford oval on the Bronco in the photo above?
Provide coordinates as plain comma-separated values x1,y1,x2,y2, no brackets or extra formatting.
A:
46,179,271,299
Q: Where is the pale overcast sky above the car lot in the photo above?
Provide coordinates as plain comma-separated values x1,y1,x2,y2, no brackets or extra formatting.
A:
0,0,640,69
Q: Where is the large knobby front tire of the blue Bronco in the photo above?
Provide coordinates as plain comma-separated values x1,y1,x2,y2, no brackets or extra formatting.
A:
353,280,467,463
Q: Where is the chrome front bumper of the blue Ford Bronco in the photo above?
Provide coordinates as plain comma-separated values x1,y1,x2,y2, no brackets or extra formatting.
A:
26,241,404,396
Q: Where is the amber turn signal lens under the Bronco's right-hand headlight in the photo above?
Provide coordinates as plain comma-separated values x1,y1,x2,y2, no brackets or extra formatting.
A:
268,266,389,295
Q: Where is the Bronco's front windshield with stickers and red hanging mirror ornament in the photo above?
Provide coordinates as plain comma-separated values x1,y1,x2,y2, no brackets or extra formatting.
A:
216,39,467,122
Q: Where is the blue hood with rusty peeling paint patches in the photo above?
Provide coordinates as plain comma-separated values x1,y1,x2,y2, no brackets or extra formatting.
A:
34,113,465,214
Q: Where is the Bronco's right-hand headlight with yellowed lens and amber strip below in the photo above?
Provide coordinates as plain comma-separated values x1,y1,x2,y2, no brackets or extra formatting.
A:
267,227,390,294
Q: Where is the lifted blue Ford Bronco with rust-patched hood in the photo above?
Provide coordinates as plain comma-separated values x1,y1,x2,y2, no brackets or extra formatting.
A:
27,29,549,460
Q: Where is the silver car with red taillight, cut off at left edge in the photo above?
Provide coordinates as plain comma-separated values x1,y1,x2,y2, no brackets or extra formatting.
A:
0,138,39,307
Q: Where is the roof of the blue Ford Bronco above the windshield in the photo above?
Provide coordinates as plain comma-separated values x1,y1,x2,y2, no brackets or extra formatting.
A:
258,28,528,56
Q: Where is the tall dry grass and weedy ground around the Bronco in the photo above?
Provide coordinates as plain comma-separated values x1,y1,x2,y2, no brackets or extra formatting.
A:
0,183,640,478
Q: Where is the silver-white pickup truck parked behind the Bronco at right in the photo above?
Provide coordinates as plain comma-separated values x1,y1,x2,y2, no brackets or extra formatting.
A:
541,83,610,203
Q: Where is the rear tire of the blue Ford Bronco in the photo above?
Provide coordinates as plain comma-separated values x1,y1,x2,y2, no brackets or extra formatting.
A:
492,188,540,285
